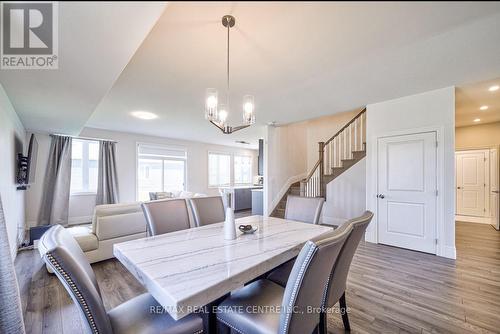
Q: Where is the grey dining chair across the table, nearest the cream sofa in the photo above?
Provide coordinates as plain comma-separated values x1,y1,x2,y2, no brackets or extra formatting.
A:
141,198,190,235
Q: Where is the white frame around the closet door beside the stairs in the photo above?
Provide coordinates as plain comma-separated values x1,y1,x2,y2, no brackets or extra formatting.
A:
365,127,446,257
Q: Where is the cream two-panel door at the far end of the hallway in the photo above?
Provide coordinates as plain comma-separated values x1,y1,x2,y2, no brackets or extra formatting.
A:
455,150,489,217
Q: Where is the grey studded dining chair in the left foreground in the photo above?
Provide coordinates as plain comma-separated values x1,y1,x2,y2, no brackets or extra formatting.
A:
39,225,203,334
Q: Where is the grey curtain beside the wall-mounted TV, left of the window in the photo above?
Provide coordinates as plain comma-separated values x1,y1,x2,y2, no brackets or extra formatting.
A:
38,136,72,226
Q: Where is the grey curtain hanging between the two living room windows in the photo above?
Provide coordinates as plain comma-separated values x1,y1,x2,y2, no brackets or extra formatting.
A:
96,141,119,205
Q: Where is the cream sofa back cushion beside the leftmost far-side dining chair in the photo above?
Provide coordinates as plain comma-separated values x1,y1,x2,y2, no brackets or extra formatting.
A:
95,209,146,240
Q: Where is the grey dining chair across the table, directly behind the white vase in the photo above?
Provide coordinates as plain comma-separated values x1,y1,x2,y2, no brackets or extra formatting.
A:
189,196,226,227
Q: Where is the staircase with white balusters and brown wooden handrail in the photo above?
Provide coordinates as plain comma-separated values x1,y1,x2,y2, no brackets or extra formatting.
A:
271,108,366,218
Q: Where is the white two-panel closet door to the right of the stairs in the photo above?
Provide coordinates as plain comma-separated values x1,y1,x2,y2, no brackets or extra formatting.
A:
377,132,437,254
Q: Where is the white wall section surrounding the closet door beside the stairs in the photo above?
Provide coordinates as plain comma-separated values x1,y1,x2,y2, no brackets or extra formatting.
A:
366,87,455,258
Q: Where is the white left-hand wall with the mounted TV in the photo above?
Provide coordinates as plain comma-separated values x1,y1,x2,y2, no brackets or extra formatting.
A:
0,85,26,258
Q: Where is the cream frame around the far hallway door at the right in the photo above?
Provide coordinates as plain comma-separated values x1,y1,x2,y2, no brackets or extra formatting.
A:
455,147,494,224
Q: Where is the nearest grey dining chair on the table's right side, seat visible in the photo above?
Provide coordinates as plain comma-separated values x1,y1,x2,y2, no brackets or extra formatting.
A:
217,222,350,334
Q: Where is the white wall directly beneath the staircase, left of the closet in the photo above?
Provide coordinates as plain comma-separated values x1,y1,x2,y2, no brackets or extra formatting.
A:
321,158,366,226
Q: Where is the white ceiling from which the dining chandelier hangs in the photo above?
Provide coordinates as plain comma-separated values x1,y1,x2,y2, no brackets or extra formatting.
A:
0,2,500,147
